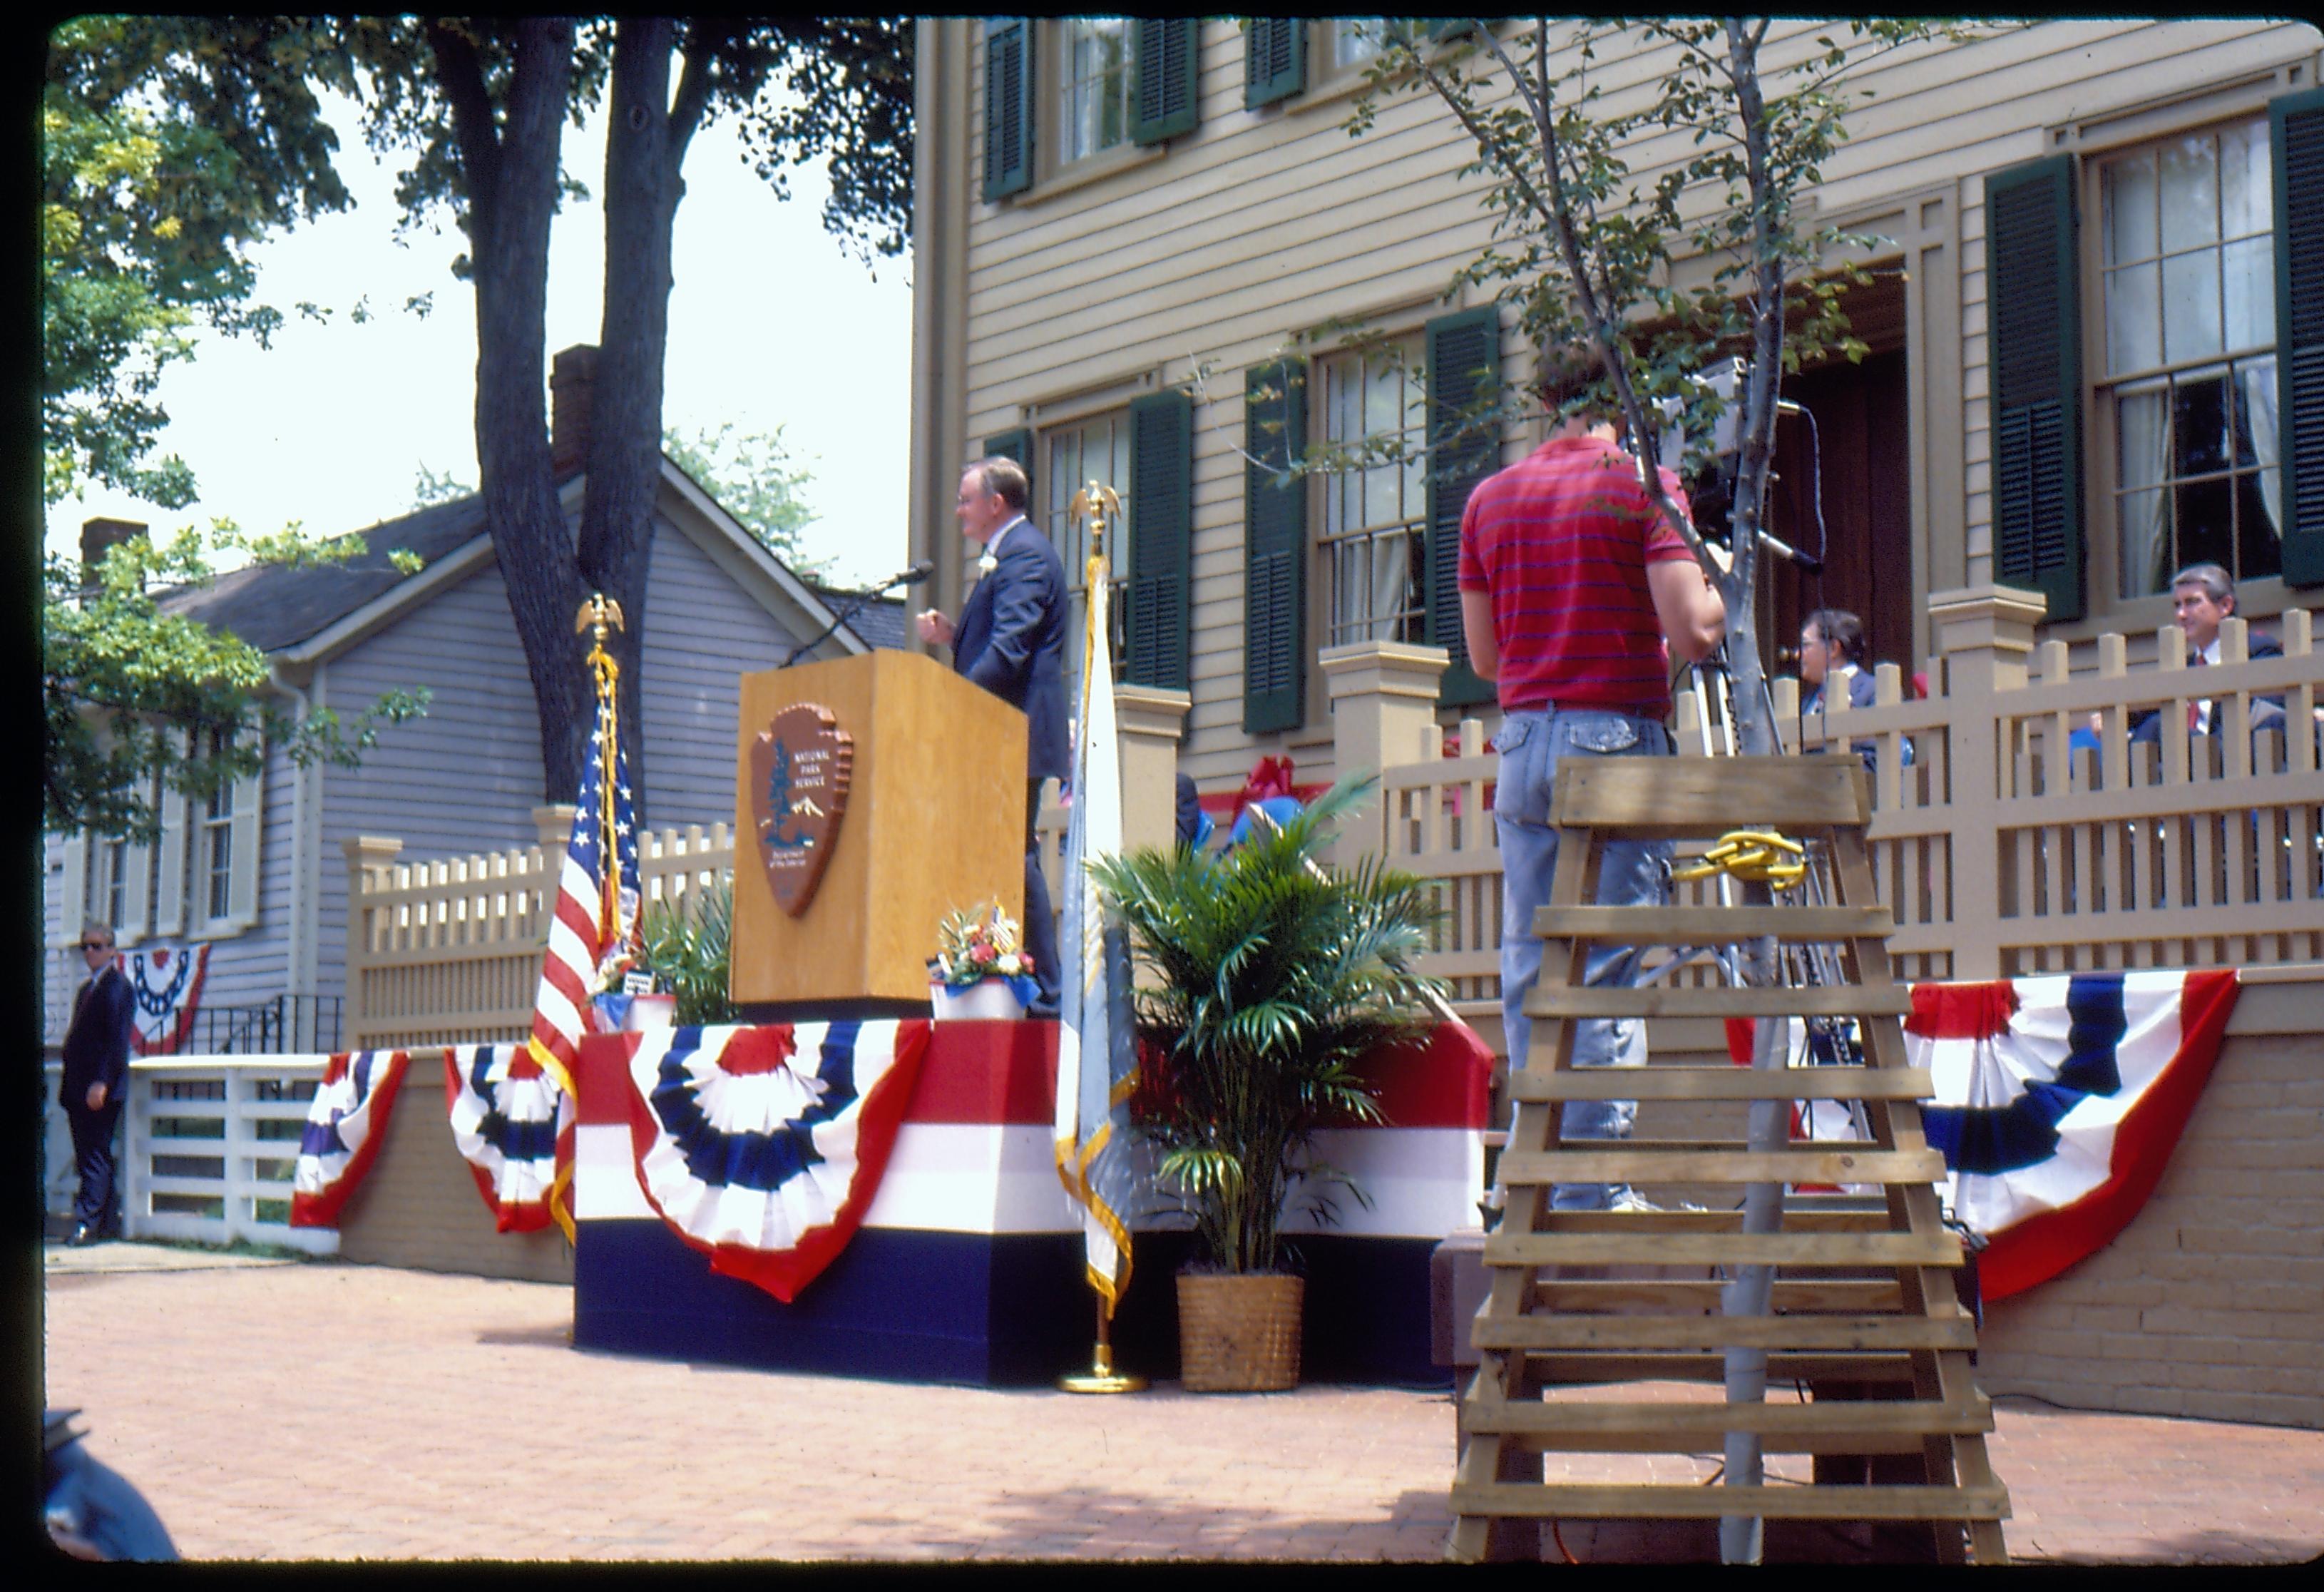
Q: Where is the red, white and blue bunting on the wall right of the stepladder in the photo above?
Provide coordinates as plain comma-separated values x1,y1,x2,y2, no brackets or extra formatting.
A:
1726,969,2238,1299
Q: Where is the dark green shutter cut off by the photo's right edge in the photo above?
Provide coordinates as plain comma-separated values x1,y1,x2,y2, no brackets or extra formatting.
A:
2268,88,2324,586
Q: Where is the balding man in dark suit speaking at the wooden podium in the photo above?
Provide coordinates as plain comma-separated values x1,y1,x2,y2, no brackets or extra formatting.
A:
913,458,1074,1016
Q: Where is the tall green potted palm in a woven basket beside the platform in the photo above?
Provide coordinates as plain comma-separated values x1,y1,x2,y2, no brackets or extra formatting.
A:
1090,776,1441,1390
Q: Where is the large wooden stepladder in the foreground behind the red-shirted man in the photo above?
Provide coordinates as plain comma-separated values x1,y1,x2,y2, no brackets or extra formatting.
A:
1450,755,2010,1564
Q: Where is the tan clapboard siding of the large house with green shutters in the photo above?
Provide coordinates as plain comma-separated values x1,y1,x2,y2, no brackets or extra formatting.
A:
916,19,2319,790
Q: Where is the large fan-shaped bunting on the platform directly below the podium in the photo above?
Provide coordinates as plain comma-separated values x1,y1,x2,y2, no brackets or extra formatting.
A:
628,1020,927,1304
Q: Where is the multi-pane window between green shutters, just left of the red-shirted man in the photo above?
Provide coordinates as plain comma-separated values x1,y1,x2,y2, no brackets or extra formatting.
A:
1320,347,1427,646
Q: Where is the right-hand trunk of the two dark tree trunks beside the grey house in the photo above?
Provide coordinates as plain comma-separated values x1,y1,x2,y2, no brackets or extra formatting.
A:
578,16,685,825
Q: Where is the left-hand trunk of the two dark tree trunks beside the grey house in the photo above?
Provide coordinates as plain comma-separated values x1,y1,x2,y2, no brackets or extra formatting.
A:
451,16,590,802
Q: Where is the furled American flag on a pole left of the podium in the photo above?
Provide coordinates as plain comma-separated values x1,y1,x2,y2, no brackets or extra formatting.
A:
511,690,639,1239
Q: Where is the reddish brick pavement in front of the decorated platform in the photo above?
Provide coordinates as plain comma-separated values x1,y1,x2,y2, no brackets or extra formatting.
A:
46,1245,2324,1564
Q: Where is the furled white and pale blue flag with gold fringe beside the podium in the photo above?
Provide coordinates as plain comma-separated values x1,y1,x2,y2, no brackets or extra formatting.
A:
1058,558,1137,1318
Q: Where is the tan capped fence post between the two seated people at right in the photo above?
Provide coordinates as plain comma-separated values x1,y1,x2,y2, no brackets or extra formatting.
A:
1929,586,2047,979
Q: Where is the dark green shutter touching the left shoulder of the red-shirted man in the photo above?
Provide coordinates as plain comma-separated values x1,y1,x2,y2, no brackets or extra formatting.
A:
1420,305,1501,707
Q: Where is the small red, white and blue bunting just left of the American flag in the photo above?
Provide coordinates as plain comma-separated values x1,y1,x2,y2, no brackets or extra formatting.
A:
444,1046,574,1232
